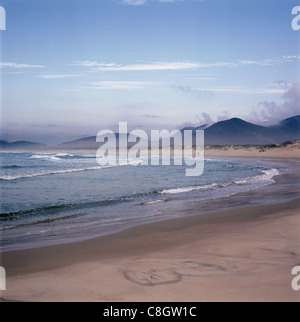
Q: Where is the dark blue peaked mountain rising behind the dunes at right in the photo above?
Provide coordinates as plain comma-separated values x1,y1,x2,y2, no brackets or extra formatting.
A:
185,116,300,145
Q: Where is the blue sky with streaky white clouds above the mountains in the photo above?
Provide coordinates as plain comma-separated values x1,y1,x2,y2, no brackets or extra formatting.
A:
0,0,300,143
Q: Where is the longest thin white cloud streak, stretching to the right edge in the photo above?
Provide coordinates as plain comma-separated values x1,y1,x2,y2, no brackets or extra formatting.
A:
72,55,300,72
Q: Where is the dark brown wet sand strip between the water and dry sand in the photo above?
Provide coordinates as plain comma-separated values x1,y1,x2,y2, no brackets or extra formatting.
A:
1,197,300,277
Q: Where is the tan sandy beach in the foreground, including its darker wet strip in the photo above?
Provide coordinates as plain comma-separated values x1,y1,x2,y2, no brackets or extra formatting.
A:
1,153,300,302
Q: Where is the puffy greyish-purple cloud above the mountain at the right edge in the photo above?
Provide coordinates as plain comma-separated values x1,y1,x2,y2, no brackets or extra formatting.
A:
251,82,300,123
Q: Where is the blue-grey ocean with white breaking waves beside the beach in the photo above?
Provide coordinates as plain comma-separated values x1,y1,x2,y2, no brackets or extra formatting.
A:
0,153,284,251
